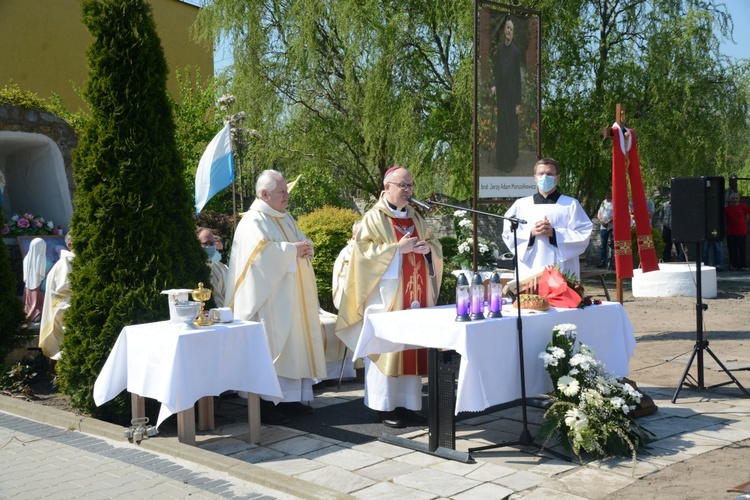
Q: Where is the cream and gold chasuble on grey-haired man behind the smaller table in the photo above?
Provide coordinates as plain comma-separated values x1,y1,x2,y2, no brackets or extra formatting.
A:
225,199,326,379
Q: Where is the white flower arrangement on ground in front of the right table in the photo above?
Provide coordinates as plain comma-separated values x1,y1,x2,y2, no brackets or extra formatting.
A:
539,324,653,460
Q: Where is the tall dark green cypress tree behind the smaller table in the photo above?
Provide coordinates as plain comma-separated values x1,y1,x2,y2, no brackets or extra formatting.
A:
58,0,210,421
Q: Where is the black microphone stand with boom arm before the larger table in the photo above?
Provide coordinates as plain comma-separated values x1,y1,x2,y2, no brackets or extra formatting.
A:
409,197,571,462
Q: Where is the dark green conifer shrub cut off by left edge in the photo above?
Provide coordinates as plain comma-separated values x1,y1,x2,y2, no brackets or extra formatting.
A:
0,230,32,363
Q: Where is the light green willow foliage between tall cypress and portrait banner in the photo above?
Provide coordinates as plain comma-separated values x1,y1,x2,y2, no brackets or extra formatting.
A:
196,0,473,203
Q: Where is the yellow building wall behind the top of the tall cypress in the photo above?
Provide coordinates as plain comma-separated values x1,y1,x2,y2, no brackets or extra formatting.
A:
0,0,214,111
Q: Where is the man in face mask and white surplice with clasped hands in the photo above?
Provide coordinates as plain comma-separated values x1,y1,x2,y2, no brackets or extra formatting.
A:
503,158,593,279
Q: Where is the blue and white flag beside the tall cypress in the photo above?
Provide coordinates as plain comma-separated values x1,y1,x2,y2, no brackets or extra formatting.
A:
195,122,234,214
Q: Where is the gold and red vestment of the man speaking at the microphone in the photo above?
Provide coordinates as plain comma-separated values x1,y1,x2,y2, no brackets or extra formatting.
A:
336,194,443,376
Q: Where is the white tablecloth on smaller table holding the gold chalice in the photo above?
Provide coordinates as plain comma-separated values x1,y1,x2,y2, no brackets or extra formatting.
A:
94,320,282,427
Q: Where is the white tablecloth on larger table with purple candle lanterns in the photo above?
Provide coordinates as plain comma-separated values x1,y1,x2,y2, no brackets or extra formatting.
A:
354,302,635,413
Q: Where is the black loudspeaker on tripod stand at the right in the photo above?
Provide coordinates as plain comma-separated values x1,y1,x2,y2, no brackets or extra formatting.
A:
671,177,724,243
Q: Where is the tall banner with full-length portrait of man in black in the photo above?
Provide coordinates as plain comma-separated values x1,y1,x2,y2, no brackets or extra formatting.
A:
474,0,541,198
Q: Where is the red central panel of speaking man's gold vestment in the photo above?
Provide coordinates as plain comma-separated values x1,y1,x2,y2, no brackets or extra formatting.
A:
391,217,427,375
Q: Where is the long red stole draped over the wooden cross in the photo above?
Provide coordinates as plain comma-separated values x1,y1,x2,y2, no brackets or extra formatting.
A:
612,124,659,278
